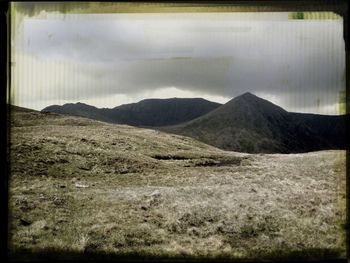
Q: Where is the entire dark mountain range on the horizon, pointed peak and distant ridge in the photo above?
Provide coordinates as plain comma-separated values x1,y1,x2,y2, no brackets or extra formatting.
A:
42,93,348,153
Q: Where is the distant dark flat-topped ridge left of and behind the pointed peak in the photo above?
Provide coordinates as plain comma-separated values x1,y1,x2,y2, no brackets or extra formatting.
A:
42,98,221,127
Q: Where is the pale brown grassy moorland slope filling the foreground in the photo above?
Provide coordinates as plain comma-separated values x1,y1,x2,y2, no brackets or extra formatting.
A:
9,109,345,260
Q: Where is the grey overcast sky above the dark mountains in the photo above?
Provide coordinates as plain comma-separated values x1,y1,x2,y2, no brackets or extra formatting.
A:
12,10,345,114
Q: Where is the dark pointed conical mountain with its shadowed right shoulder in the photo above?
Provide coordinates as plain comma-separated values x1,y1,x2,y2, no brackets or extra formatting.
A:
161,93,346,153
